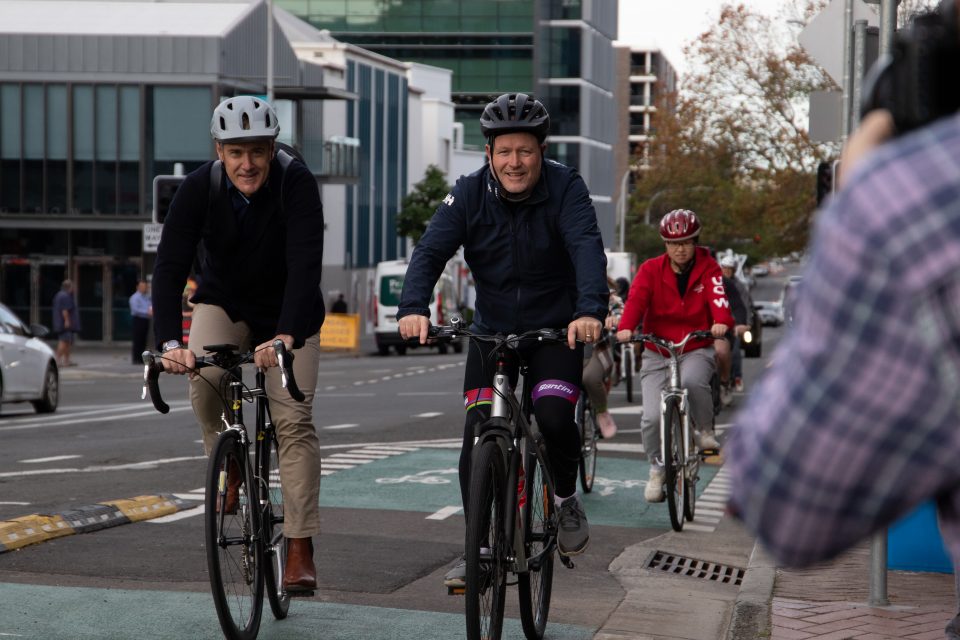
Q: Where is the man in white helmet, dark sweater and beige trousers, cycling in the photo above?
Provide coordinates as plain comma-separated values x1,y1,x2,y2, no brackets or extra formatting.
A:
153,96,324,593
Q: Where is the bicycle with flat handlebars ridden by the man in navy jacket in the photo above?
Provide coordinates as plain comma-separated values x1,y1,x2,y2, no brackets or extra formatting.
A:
429,318,573,640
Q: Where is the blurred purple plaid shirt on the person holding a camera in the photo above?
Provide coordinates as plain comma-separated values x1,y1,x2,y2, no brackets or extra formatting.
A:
725,116,960,565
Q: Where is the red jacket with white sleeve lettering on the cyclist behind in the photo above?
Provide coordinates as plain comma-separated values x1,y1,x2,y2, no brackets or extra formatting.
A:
617,247,735,351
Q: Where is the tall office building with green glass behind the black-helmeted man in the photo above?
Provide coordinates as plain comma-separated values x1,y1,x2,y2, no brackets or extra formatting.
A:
275,0,622,246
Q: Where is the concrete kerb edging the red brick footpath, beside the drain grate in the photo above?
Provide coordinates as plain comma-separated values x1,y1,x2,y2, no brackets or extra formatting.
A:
725,542,777,640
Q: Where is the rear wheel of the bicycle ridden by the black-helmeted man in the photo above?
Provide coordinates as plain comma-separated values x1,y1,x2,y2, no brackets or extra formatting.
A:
517,444,556,640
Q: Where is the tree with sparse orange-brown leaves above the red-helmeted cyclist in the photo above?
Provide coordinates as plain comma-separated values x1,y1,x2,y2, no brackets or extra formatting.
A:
628,0,838,257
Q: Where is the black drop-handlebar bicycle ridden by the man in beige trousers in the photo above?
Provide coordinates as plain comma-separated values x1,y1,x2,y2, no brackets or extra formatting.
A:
143,340,304,640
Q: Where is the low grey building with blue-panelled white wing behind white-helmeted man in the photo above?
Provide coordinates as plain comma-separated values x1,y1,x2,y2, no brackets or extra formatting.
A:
0,0,408,342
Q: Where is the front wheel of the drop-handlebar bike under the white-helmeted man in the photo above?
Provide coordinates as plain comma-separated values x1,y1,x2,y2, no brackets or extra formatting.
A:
204,429,263,640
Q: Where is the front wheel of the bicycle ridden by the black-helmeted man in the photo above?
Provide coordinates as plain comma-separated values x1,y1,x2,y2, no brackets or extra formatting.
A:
465,441,510,640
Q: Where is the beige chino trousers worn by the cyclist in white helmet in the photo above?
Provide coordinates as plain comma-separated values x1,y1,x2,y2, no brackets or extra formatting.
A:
189,304,320,538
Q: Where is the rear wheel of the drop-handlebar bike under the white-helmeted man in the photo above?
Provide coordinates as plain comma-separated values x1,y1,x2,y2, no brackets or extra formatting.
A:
260,427,290,620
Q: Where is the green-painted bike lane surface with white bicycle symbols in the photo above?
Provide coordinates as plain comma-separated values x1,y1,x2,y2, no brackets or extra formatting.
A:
0,446,717,640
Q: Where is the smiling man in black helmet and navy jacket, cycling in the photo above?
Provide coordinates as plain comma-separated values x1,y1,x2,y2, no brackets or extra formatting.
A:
397,93,609,587
